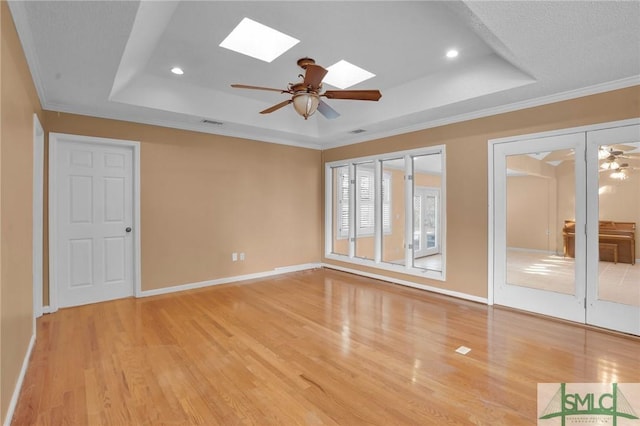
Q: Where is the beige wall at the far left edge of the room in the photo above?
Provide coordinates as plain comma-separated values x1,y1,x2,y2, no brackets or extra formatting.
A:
0,1,41,420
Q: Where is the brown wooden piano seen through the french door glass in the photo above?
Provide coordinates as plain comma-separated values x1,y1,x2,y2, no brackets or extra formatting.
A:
562,220,636,265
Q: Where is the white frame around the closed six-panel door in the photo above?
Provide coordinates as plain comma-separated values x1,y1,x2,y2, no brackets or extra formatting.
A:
48,133,142,312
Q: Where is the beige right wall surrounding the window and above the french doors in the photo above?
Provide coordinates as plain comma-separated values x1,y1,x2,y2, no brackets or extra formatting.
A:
323,86,640,297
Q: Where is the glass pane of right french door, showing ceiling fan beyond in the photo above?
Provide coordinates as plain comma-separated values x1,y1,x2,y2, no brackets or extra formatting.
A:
597,142,640,306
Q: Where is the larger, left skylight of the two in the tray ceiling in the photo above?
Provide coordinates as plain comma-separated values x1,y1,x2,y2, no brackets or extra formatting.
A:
220,18,300,62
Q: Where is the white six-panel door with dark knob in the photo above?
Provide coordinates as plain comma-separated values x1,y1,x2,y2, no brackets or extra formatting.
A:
50,134,135,307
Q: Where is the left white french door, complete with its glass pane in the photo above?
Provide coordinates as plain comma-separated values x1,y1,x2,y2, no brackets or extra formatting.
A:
493,133,586,322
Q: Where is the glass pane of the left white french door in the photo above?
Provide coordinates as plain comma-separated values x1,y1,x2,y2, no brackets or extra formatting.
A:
506,149,576,295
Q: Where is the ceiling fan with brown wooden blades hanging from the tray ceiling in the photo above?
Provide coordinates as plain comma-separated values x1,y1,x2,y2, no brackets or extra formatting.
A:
231,58,382,120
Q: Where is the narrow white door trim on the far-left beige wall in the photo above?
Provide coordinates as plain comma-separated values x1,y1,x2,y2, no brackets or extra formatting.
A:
32,114,44,322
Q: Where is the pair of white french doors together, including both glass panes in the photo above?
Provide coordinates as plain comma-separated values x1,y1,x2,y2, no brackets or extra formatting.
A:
490,120,640,335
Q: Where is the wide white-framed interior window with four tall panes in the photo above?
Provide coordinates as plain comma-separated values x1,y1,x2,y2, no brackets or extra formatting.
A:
325,146,446,279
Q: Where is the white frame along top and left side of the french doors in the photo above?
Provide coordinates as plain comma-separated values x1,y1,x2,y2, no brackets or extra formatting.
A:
487,118,640,305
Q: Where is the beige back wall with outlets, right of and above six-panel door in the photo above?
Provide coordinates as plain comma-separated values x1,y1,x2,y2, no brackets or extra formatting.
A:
45,111,322,294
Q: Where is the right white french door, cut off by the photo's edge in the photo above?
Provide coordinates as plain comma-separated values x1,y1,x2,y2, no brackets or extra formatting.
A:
586,125,640,335
